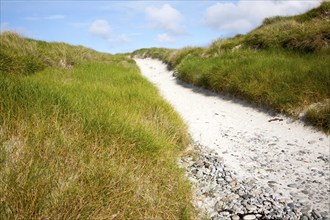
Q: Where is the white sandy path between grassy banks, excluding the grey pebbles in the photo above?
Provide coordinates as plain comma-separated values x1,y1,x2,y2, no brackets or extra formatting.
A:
135,59,330,211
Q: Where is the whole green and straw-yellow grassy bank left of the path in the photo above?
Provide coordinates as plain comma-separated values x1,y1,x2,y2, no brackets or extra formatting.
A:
0,33,192,219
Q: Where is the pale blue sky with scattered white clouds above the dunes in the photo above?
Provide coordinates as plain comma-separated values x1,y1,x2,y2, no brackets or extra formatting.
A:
0,0,321,53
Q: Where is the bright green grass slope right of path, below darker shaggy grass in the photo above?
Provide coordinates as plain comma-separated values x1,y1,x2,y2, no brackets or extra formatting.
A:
177,50,330,109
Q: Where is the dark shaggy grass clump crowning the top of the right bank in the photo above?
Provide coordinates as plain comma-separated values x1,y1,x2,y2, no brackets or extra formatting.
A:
243,2,330,52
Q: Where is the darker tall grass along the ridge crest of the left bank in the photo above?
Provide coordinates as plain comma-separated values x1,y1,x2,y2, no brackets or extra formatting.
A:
0,32,111,74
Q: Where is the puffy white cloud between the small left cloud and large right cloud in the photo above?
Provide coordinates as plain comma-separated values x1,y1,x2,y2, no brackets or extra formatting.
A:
146,4,186,35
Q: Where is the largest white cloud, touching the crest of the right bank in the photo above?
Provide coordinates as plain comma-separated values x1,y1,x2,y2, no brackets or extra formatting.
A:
204,0,321,34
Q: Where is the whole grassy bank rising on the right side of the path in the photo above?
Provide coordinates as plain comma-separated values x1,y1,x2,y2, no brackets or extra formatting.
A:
133,2,330,133
